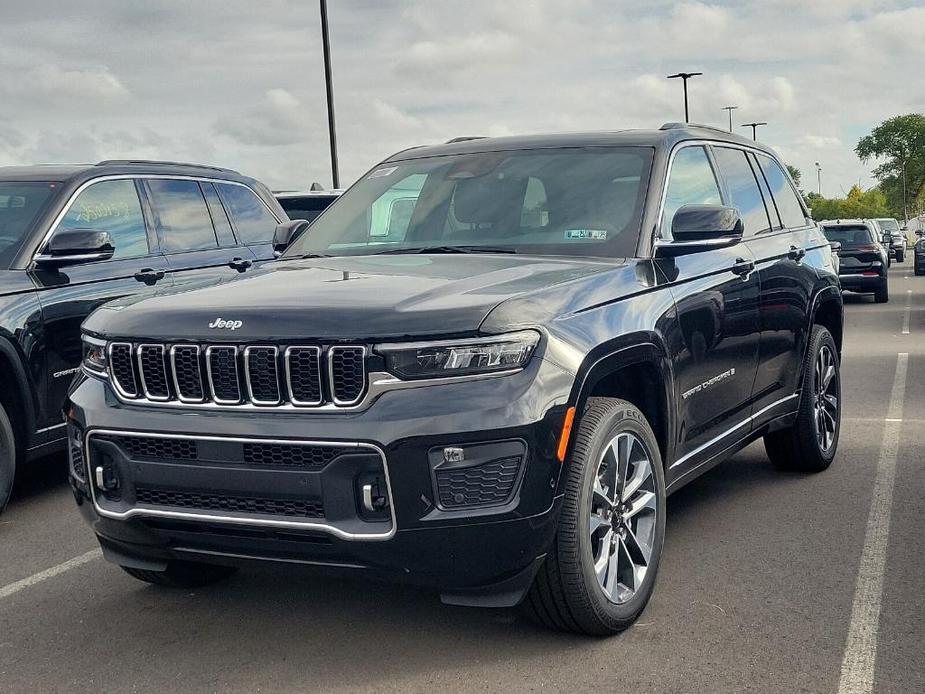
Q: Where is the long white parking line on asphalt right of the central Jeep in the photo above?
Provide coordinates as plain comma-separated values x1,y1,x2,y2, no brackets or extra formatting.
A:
838,352,909,694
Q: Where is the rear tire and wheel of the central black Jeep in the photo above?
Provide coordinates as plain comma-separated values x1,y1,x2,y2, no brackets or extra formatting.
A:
764,325,841,472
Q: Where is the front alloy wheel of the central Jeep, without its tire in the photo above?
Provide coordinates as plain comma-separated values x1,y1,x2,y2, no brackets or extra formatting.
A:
589,431,658,605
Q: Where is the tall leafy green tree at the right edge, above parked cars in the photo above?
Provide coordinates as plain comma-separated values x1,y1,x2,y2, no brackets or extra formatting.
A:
854,113,925,217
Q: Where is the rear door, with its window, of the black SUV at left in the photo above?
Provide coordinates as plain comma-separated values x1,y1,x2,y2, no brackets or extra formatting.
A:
145,178,255,289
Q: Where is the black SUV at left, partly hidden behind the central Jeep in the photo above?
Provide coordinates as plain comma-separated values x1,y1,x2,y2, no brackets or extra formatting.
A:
0,161,287,510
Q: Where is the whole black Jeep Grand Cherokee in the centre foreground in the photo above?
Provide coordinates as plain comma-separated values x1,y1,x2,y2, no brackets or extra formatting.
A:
69,125,842,634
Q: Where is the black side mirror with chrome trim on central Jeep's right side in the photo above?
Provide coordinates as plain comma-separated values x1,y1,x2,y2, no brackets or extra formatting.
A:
656,205,744,257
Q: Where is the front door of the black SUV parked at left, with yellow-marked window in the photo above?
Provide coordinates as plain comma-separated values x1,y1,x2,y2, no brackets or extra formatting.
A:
30,178,171,427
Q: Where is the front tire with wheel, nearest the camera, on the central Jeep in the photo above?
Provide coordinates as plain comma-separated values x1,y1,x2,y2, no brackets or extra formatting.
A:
523,398,665,636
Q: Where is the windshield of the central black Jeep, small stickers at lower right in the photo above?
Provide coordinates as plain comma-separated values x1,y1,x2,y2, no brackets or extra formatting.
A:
283,147,653,258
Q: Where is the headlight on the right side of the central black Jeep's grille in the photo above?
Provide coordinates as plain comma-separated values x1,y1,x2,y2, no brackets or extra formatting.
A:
376,330,540,379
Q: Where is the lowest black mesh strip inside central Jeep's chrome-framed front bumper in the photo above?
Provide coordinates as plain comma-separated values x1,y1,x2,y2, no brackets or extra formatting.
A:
135,487,324,518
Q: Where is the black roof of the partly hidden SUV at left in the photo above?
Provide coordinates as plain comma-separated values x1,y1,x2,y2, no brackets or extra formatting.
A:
0,159,246,181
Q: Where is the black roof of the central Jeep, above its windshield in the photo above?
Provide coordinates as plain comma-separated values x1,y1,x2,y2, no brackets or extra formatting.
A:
386,123,771,161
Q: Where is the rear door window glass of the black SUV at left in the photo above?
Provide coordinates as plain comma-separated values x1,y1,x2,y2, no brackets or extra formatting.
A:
148,179,218,253
